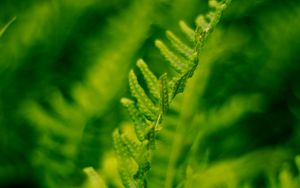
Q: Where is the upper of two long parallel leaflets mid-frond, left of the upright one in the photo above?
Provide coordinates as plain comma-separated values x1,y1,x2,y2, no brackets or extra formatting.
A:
136,59,159,99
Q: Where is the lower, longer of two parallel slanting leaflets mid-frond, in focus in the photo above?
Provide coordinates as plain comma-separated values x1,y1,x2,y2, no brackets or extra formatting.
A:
129,70,158,120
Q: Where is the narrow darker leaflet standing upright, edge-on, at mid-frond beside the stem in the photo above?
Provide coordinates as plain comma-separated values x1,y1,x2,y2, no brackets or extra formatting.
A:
159,73,169,114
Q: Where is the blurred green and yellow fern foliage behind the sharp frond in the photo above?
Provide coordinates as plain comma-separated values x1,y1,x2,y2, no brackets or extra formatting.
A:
0,0,300,188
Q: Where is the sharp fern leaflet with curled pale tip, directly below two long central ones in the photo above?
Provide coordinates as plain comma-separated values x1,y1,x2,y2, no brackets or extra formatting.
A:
121,98,150,141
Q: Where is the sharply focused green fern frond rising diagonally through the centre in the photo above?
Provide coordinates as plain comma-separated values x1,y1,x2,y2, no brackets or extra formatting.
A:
114,1,231,187
